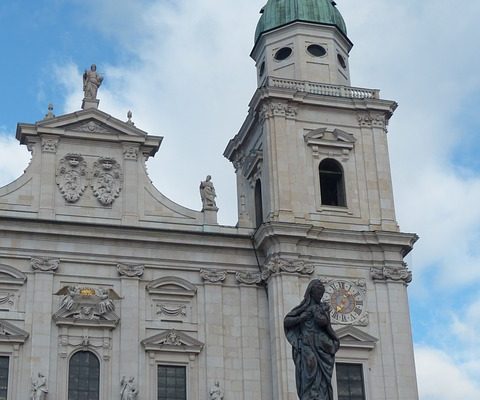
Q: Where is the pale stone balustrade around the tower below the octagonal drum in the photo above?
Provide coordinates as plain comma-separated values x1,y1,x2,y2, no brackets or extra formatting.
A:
265,76,380,99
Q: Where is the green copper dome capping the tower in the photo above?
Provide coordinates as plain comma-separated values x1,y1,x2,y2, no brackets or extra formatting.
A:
255,0,347,43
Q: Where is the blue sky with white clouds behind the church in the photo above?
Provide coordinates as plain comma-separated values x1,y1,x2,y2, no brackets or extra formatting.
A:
0,0,480,400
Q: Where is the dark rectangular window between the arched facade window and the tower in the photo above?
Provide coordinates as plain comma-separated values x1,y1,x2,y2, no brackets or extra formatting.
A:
157,365,187,400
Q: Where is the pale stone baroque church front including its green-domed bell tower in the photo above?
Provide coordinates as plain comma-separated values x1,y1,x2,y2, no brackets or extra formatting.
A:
0,0,418,400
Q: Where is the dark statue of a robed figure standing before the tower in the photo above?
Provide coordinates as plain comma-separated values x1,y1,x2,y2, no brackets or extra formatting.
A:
284,279,340,400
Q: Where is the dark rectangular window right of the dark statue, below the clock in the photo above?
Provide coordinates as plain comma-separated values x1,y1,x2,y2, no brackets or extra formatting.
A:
336,363,365,400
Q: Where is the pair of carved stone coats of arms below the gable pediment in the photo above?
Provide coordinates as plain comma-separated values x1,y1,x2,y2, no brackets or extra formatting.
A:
56,153,123,206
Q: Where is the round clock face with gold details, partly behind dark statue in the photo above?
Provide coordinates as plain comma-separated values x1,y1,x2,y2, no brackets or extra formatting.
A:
323,280,365,324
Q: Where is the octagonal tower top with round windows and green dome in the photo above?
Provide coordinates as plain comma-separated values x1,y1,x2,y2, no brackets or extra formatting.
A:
251,0,353,87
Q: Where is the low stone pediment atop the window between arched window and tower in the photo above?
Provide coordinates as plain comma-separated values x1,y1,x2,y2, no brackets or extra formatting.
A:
142,329,204,354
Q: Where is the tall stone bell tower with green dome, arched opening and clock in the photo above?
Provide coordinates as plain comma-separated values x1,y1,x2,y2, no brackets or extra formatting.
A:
224,0,418,400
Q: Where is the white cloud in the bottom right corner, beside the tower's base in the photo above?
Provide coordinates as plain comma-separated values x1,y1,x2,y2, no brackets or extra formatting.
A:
415,346,480,400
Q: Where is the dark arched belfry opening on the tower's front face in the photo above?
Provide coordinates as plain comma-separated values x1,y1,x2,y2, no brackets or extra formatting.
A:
319,158,347,207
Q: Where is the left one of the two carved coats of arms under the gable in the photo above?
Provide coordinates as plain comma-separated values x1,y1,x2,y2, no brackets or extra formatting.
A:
56,153,87,203
